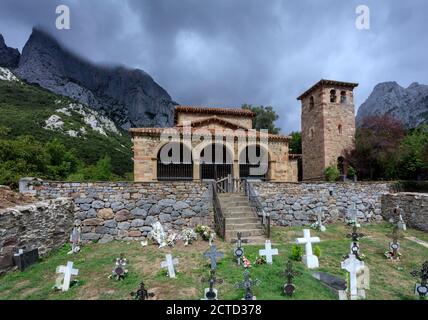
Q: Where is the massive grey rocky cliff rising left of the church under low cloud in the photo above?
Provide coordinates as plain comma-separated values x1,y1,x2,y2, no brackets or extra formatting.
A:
14,29,175,129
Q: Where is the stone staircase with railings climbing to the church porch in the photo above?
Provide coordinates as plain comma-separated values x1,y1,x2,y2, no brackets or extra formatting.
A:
218,193,266,244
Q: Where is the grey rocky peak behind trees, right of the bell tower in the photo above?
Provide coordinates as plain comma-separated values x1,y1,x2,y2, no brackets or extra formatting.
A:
357,82,428,128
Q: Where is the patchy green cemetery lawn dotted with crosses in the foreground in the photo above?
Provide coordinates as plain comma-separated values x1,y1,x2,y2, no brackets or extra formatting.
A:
0,223,428,300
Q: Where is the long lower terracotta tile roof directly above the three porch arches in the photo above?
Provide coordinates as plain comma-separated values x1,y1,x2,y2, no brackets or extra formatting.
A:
129,127,291,141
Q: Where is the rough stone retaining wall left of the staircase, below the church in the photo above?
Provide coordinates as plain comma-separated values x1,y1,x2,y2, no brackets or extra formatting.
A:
36,182,212,243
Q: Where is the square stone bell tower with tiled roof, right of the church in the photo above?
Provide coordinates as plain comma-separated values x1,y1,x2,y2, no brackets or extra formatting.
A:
297,80,358,181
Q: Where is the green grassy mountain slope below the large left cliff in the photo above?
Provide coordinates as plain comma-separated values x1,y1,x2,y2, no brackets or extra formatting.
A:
0,81,133,176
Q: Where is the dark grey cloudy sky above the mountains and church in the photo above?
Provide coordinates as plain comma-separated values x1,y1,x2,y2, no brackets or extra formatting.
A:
0,0,428,133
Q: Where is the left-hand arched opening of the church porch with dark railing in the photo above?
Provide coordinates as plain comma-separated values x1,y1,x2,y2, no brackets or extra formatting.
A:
157,142,193,181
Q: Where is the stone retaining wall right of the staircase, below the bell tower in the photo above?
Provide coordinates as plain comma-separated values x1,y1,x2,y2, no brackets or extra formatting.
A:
253,183,392,226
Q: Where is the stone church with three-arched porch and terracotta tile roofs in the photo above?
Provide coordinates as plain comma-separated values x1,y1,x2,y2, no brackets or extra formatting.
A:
130,106,298,182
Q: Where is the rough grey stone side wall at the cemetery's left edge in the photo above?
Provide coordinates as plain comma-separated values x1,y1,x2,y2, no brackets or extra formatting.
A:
0,198,74,273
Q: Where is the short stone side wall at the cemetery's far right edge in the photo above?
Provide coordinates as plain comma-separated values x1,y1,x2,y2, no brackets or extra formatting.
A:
382,192,428,232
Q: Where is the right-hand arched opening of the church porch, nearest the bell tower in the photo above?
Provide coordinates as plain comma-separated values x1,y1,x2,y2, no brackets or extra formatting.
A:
239,145,269,181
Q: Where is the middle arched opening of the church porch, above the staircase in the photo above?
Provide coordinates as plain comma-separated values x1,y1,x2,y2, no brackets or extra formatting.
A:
200,143,233,180
